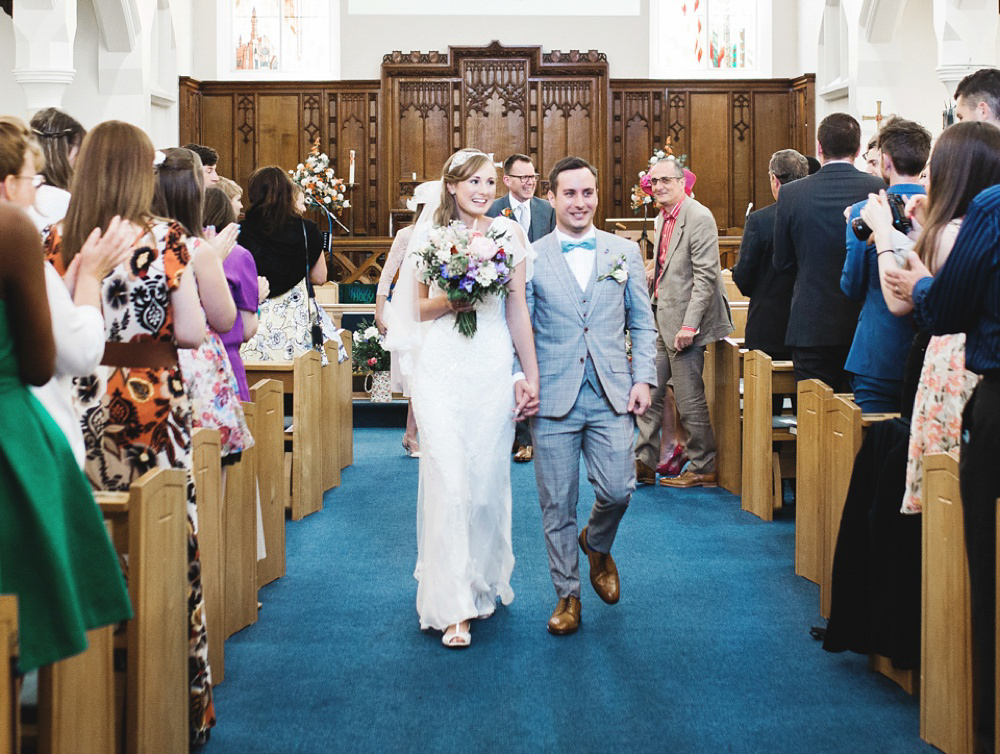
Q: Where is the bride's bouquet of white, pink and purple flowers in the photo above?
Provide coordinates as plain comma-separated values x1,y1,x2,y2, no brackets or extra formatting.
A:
416,222,511,338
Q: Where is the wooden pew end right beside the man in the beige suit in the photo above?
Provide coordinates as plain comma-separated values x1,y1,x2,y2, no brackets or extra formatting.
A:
705,338,743,495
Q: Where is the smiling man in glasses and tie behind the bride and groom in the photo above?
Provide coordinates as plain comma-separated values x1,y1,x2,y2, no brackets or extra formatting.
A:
486,154,556,463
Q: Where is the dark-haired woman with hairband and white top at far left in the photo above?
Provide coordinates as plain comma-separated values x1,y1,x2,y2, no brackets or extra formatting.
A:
28,107,87,230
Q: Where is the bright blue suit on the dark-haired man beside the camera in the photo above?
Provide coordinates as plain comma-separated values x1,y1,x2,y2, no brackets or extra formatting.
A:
840,183,925,380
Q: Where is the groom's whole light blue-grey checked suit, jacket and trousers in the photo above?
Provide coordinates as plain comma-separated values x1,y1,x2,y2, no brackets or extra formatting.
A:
527,230,656,597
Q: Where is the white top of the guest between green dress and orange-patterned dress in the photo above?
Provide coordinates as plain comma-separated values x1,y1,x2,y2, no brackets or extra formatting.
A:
31,263,104,469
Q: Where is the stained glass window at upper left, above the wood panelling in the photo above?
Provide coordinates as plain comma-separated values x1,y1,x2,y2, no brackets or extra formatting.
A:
232,0,330,72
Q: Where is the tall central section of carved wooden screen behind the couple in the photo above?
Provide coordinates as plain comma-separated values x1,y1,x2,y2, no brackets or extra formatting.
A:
381,42,610,226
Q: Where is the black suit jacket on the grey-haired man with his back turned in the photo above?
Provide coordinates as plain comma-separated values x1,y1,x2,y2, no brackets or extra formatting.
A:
733,204,795,355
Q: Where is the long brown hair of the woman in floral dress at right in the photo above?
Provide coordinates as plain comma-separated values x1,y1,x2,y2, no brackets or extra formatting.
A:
914,120,1000,272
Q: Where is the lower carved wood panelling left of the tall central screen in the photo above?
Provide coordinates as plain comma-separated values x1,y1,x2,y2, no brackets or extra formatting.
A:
180,78,385,235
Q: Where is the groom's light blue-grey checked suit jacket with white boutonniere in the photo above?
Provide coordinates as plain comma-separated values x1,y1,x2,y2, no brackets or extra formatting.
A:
527,230,656,419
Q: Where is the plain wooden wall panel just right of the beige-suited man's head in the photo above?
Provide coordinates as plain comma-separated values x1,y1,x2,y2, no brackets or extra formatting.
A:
688,93,732,227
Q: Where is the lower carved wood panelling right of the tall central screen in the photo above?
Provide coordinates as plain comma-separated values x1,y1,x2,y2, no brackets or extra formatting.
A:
608,75,814,229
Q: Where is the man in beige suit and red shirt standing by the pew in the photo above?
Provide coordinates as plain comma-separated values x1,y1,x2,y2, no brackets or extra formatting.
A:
636,159,733,487
